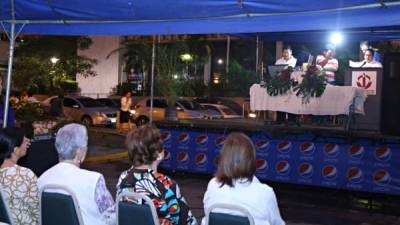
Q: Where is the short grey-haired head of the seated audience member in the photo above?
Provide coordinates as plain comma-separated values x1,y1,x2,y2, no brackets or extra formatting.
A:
55,123,88,160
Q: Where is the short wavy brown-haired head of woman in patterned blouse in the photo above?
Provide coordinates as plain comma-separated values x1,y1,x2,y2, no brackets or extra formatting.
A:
125,125,163,166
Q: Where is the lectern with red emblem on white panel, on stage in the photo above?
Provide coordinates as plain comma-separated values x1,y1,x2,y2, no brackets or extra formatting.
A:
344,68,383,132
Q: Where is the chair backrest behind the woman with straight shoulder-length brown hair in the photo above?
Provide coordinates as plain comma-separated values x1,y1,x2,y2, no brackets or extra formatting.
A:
206,203,254,225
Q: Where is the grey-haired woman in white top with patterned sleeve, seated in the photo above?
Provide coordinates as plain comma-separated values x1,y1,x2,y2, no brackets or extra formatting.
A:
38,124,116,225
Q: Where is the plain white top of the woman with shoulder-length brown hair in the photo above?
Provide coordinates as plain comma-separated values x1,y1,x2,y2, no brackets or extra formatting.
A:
203,177,285,225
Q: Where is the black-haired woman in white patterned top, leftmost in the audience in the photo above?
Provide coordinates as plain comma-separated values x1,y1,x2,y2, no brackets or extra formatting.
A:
0,128,39,225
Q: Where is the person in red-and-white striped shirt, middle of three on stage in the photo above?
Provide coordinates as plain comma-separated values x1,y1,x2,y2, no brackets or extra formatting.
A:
315,46,339,84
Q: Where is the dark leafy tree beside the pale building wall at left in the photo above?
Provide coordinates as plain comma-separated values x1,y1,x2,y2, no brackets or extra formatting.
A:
13,36,96,94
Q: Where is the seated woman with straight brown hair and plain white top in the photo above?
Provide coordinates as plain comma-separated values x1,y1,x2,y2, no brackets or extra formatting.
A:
203,133,285,225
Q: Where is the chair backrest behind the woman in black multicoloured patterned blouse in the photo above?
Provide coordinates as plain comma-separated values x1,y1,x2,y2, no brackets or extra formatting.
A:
117,191,159,225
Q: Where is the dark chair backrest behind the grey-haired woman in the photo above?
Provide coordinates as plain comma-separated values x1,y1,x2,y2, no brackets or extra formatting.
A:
40,185,83,225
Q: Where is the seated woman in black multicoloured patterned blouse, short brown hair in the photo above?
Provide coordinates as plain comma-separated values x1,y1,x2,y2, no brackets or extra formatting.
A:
117,125,196,225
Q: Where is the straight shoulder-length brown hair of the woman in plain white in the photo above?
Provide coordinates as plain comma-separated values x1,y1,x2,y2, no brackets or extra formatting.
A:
215,133,256,187
